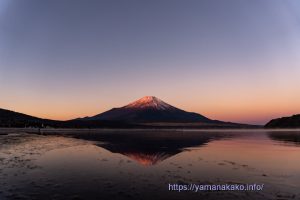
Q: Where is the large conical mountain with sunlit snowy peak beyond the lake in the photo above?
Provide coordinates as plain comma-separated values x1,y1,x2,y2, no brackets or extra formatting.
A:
84,96,213,122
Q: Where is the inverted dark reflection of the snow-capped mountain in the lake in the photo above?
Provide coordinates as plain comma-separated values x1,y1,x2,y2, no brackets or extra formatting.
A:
69,131,232,166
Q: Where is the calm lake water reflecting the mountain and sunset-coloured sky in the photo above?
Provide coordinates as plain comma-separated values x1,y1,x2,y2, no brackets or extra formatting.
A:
0,130,300,200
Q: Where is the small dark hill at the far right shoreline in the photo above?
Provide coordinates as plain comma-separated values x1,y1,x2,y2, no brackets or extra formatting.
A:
265,114,300,128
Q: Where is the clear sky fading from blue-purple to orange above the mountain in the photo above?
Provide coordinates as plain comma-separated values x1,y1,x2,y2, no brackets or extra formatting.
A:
0,0,300,124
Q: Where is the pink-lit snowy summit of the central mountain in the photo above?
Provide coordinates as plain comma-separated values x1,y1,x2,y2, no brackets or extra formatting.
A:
124,96,173,110
